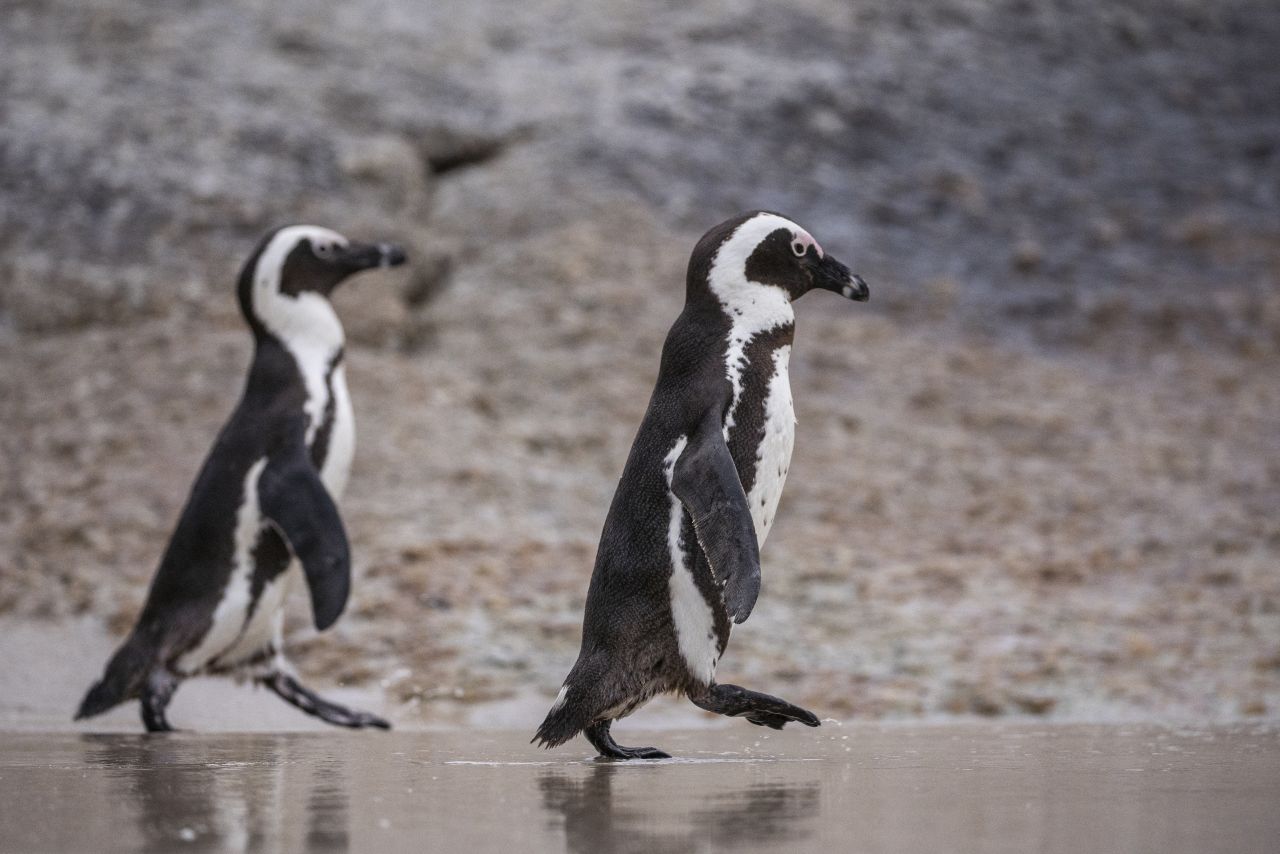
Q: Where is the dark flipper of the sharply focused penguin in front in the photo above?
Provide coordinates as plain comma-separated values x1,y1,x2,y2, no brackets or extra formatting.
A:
671,417,760,622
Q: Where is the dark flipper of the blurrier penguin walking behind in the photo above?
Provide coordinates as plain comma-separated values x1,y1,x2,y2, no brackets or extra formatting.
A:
257,442,351,631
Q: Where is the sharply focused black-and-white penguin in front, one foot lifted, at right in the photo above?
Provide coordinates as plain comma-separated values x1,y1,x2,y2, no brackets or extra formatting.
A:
534,211,869,759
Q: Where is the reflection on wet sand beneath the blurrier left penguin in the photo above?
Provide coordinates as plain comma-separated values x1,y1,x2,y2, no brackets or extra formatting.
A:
82,735,349,851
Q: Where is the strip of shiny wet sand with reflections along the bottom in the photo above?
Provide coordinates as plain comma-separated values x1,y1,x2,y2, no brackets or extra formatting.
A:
0,721,1280,854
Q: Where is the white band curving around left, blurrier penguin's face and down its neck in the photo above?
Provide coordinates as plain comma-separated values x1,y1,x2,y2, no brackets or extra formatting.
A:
253,225,347,444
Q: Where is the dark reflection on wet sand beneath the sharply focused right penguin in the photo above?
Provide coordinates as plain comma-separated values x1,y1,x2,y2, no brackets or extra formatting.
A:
538,764,820,854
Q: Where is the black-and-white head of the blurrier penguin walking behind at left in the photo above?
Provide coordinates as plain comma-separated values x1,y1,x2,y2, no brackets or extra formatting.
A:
238,225,404,337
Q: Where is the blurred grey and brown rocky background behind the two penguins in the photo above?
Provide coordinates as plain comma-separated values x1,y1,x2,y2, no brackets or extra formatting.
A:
0,0,1280,726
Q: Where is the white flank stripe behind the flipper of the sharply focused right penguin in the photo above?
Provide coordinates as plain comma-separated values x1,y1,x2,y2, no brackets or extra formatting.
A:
663,435,719,685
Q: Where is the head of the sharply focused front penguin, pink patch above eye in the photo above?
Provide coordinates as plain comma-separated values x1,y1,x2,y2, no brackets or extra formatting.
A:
689,210,870,312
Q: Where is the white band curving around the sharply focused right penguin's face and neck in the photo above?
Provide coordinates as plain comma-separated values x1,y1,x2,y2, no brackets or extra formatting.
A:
708,214,798,442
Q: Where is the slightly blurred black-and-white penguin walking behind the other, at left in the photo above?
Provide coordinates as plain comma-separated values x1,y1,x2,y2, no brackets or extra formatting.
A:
76,225,404,732
